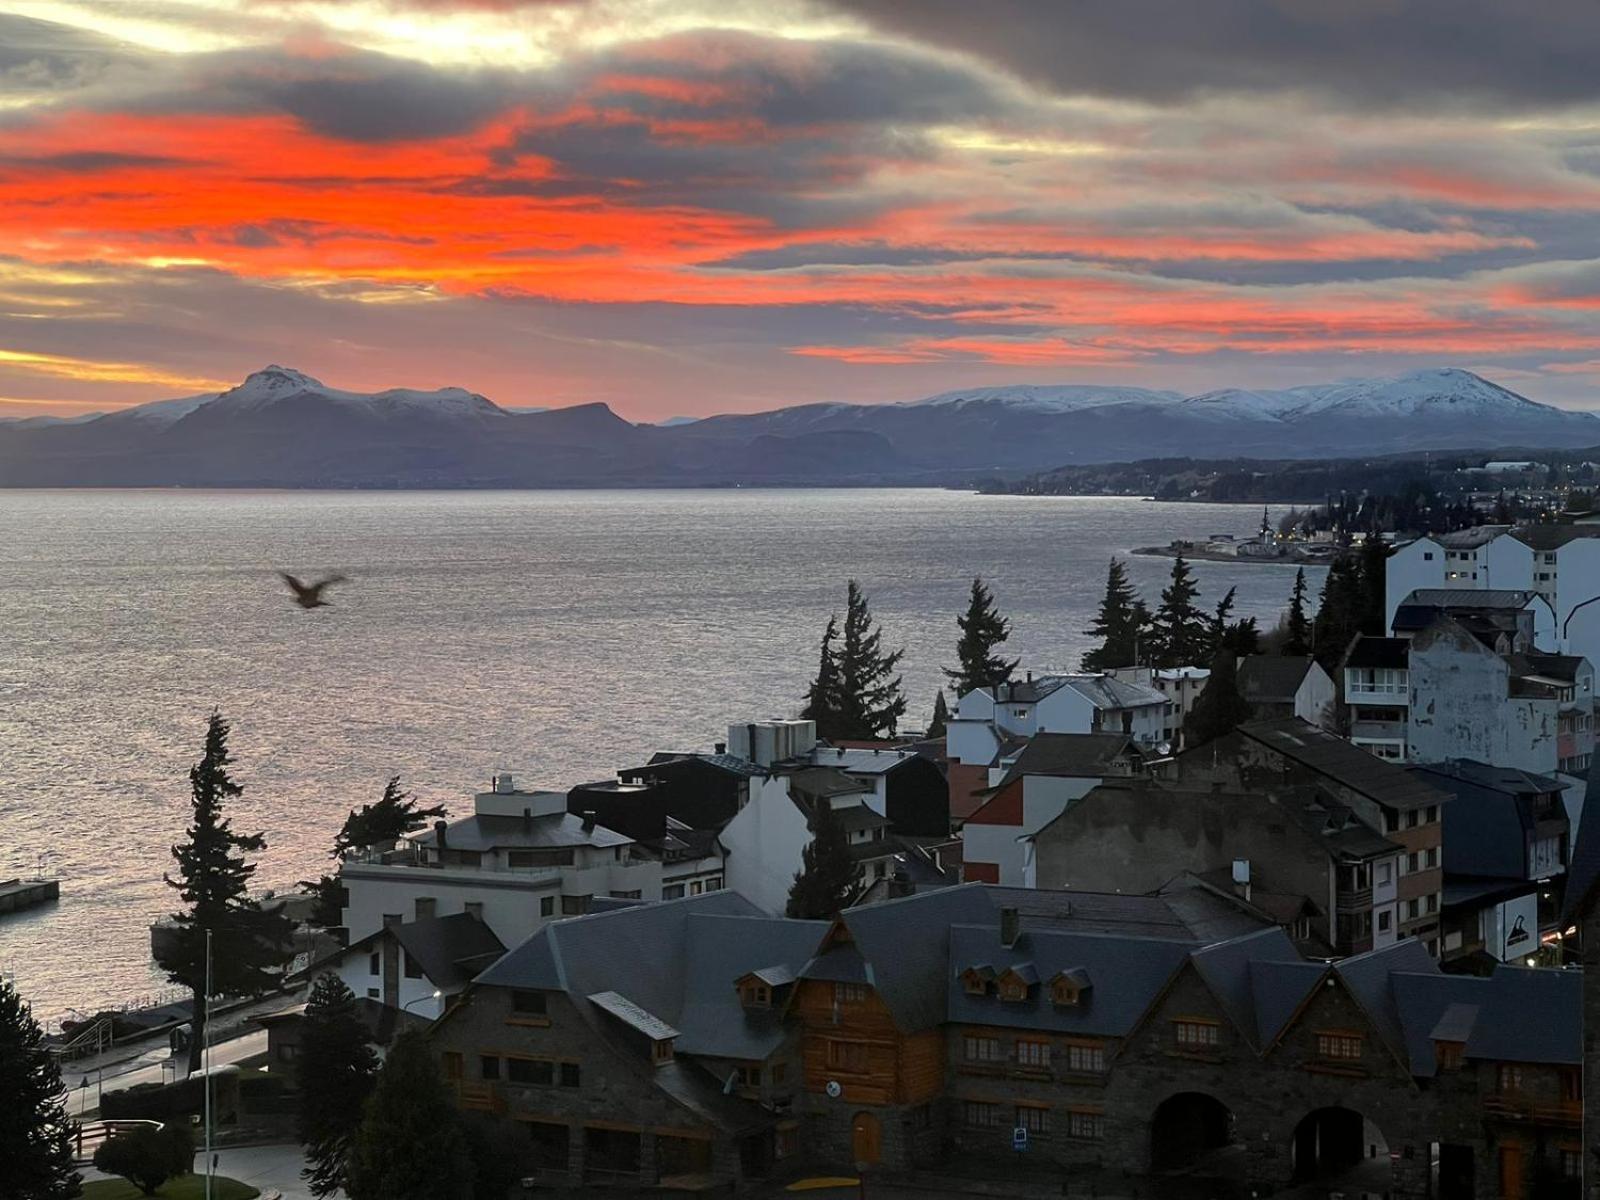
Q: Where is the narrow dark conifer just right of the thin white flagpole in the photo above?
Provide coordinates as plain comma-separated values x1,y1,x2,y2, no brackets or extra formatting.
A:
296,971,378,1197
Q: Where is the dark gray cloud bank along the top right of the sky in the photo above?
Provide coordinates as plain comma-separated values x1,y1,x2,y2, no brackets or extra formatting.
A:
834,0,1600,107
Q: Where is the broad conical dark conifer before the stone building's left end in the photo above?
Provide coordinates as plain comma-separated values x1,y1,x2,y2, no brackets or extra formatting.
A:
346,1032,474,1200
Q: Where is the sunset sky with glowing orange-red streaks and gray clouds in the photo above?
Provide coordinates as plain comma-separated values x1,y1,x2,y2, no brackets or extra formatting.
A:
0,0,1600,421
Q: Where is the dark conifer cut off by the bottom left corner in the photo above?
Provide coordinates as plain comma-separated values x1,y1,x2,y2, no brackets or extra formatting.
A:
0,976,78,1200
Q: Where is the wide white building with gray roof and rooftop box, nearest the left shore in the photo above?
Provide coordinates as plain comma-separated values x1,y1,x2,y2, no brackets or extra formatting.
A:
339,774,723,946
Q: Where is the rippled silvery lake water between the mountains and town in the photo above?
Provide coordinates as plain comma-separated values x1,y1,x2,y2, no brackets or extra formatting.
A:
0,490,1320,1018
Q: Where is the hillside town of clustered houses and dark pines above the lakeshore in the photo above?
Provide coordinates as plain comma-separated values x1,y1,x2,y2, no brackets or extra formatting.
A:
10,520,1600,1200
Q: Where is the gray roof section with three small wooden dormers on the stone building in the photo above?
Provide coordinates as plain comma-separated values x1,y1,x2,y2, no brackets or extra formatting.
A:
946,925,1194,1037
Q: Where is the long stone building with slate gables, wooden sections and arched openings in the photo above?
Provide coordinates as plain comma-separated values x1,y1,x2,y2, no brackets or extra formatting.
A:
434,885,1580,1200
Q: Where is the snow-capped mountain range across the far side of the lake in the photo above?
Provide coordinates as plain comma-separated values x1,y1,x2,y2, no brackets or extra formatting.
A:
0,366,1600,486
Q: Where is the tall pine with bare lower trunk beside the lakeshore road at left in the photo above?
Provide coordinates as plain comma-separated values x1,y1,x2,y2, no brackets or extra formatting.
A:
157,712,291,1070
